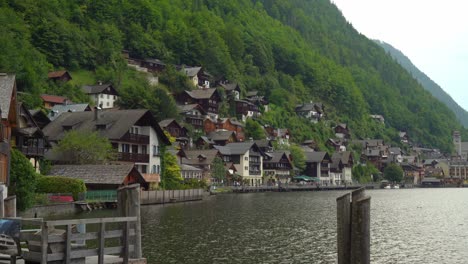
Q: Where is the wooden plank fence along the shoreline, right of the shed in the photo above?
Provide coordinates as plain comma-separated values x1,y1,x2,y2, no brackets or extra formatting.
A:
140,189,203,204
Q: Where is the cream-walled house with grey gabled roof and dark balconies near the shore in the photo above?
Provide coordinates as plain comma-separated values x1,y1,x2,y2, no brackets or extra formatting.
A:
214,142,265,186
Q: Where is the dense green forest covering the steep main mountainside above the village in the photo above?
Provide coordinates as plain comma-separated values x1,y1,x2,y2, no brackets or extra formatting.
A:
0,0,462,152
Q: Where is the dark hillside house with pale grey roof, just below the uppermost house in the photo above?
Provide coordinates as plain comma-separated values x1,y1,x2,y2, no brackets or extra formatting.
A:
176,88,221,119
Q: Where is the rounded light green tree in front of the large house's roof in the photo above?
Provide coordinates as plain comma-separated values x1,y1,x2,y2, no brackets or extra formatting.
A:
53,130,116,164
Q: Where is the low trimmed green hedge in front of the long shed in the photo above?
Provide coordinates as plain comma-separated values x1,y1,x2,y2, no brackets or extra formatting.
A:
36,176,86,200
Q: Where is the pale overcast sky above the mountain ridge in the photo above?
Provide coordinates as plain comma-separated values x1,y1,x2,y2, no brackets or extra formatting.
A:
331,0,468,110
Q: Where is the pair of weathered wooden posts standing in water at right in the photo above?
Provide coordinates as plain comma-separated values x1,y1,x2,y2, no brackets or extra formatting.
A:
336,188,370,264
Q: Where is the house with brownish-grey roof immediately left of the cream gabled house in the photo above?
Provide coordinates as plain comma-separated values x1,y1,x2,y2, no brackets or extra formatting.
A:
180,149,222,183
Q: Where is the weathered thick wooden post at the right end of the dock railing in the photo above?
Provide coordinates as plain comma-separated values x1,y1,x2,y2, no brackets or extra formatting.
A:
117,184,142,259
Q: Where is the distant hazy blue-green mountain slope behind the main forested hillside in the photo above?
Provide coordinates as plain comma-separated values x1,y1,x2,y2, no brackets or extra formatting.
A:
375,40,468,127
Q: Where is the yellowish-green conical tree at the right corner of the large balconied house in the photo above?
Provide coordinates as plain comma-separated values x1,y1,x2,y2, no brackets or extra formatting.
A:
161,152,183,190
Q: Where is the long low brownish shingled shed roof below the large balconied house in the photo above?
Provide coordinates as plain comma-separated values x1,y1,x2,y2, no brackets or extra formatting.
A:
49,164,145,185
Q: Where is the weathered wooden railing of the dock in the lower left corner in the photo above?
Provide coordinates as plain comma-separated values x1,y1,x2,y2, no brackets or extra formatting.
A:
20,217,137,264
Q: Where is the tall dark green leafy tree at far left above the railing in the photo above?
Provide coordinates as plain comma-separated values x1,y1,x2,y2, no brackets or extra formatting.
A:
8,149,37,211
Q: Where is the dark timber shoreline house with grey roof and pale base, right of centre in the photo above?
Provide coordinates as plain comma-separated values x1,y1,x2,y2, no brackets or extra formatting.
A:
304,151,335,185
